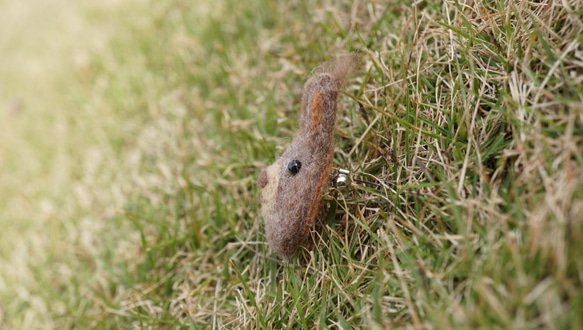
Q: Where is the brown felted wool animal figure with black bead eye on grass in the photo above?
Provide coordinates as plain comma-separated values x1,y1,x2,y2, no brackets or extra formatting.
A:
258,55,356,259
